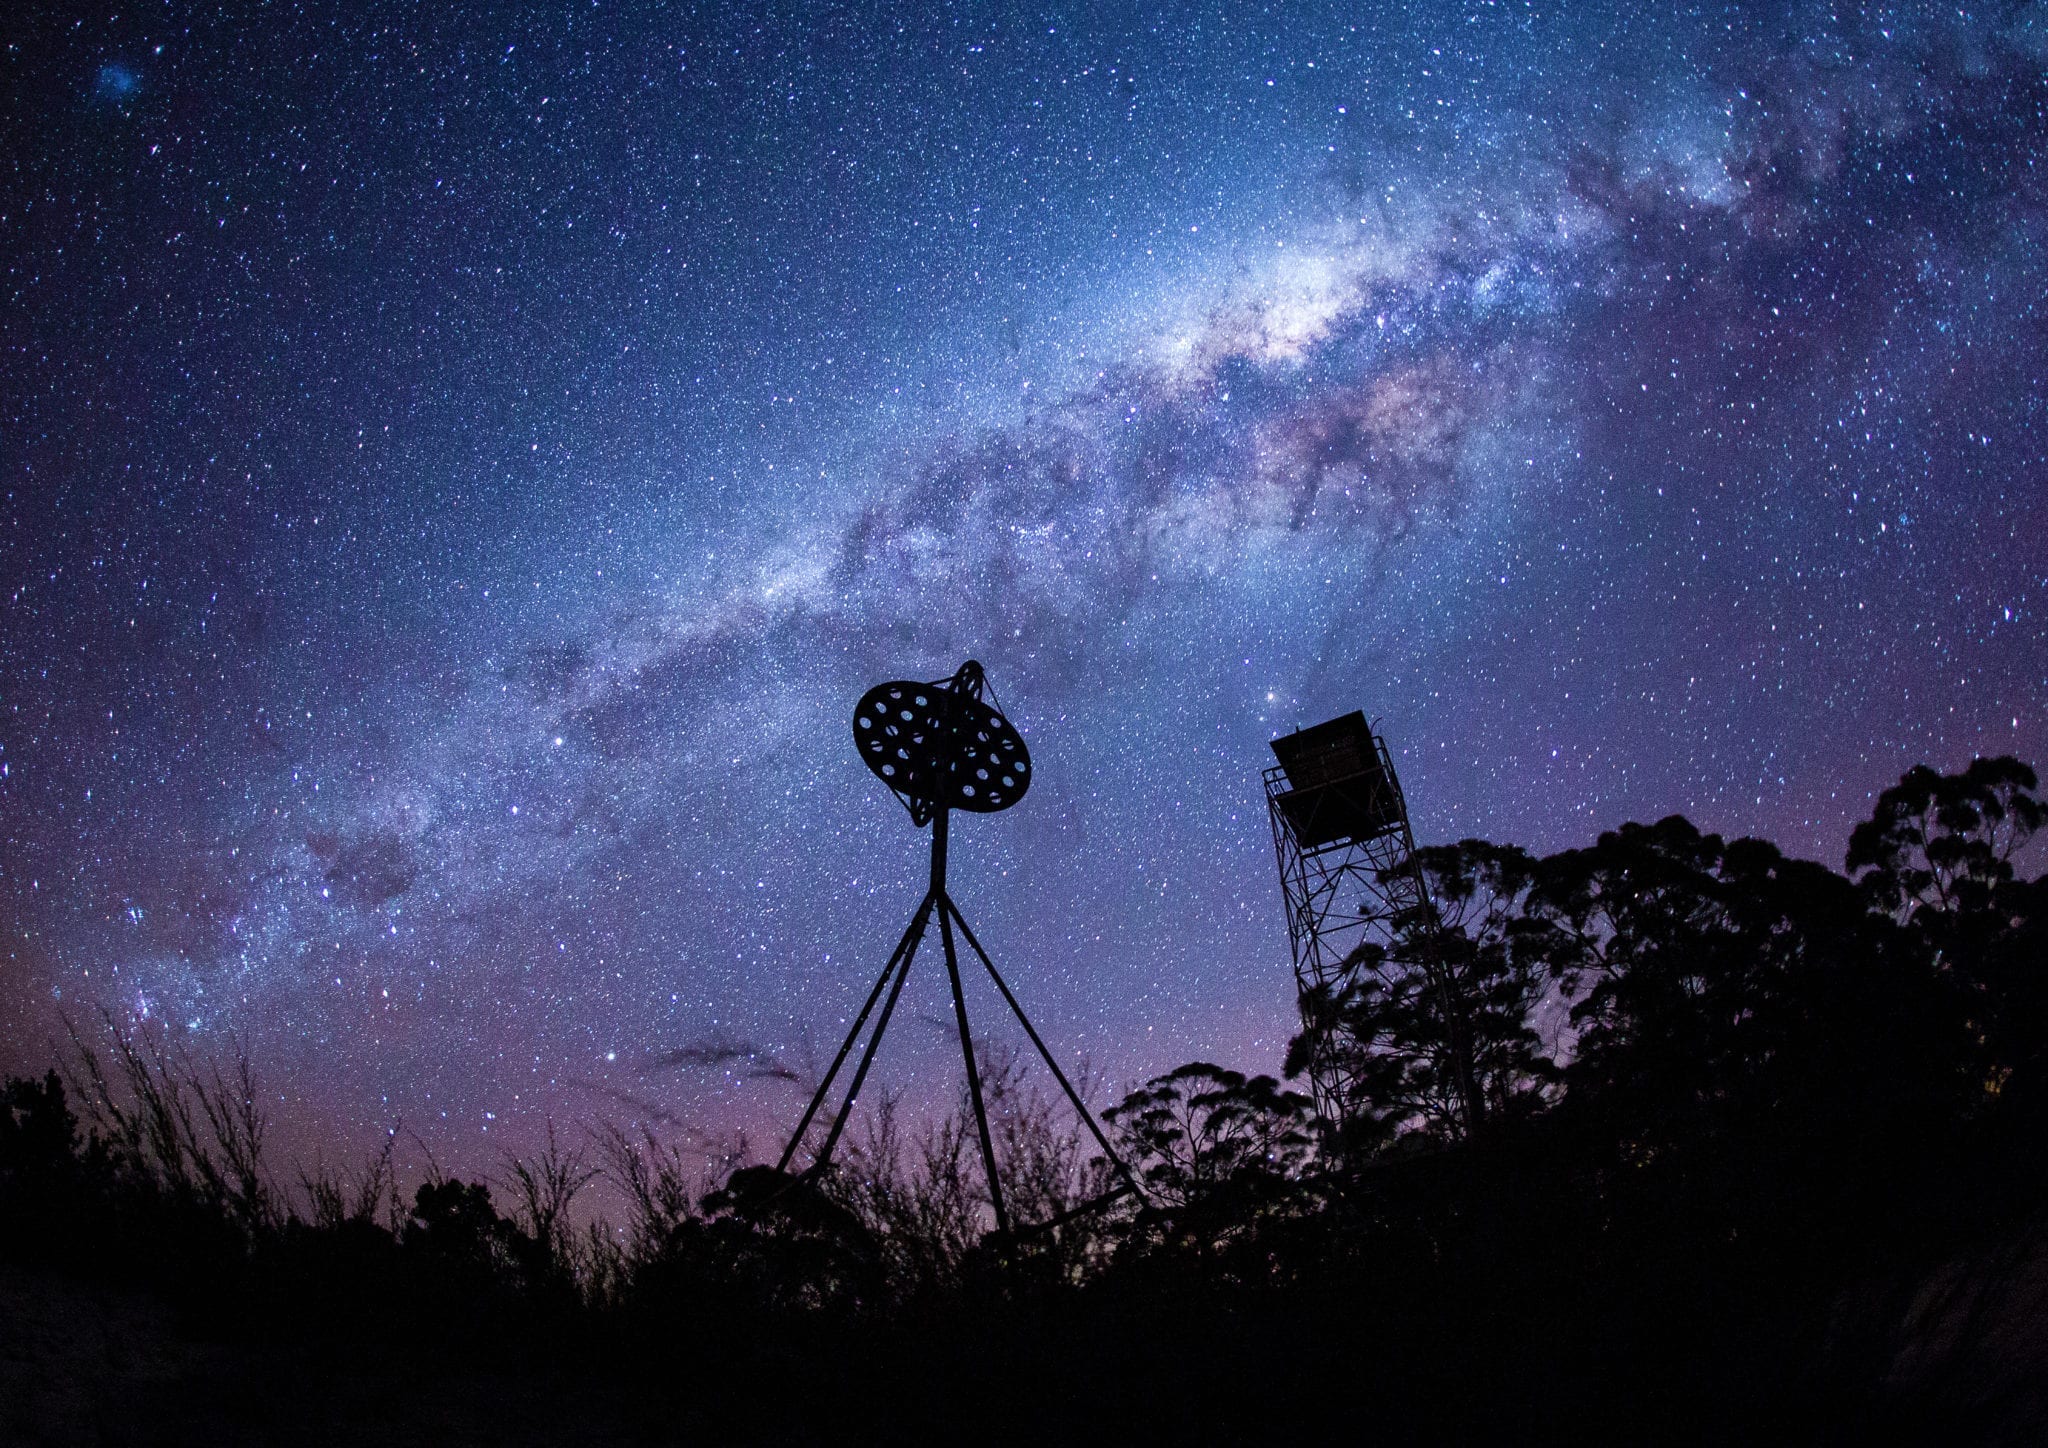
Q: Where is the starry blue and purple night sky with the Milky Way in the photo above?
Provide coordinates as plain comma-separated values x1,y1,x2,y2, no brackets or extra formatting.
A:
0,0,2048,1169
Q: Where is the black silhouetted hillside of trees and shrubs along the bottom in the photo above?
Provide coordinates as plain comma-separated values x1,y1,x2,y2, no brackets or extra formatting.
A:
0,758,2048,1444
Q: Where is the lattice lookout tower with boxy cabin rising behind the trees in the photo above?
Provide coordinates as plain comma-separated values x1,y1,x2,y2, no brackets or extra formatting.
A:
1266,713,1430,1122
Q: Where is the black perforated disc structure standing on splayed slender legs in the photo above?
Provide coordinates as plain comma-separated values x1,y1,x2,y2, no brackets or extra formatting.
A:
776,659,1143,1233
